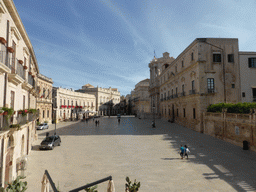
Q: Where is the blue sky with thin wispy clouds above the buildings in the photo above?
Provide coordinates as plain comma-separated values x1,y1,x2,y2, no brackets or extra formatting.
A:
14,0,256,95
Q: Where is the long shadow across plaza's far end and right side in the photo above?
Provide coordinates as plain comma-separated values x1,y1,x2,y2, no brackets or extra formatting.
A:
39,118,256,191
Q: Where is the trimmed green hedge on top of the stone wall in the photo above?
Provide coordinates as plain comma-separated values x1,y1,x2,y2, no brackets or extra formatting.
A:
207,103,256,114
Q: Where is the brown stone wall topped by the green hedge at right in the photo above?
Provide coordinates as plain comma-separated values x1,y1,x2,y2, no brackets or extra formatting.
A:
203,110,256,151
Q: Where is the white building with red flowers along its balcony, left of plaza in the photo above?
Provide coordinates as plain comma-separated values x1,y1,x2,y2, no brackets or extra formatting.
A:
52,87,96,122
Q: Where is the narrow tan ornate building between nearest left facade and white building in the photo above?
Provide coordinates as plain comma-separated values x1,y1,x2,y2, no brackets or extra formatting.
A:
36,74,53,123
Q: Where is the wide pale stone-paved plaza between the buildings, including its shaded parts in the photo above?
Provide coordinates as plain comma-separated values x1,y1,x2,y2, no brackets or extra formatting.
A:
26,117,256,192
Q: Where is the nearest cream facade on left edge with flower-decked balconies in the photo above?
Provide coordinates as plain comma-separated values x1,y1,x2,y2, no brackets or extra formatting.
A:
0,0,39,186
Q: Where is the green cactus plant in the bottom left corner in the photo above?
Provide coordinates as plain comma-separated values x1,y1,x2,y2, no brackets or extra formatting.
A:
0,176,27,192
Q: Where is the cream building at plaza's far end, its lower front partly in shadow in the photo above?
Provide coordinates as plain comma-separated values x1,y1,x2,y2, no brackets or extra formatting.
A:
76,84,120,115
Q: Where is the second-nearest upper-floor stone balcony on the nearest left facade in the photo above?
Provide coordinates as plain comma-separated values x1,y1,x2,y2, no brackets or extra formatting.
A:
8,59,25,85
